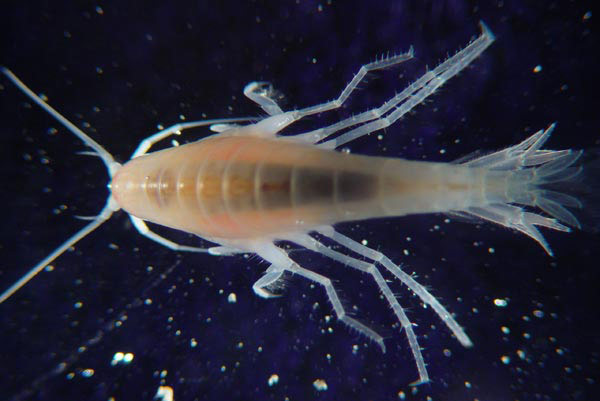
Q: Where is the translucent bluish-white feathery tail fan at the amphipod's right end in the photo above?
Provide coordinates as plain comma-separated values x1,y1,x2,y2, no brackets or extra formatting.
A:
456,123,596,256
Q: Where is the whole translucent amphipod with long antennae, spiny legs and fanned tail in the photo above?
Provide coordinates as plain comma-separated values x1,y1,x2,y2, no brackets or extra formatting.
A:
0,23,581,384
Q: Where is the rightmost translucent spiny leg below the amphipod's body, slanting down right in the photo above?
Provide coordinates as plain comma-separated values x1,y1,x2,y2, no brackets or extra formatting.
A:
318,227,473,347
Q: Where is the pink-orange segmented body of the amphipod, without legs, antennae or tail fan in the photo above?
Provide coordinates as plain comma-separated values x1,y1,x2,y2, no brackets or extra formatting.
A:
111,135,488,239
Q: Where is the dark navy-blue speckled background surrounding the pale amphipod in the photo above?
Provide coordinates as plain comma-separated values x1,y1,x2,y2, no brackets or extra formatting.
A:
0,0,600,401
